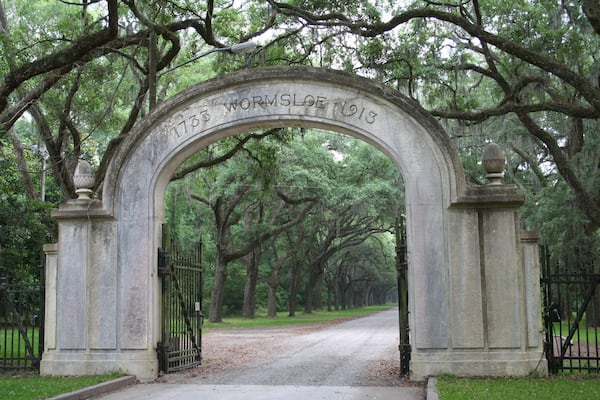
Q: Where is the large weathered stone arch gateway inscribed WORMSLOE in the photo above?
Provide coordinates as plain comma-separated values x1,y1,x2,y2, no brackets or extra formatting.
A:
41,67,545,379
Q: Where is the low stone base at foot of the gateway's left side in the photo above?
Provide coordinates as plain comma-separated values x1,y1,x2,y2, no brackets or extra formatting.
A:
40,350,158,381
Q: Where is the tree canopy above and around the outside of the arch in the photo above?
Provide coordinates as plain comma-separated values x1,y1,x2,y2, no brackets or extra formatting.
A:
0,0,600,312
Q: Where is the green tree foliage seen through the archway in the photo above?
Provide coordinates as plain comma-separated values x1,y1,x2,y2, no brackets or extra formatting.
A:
165,129,403,315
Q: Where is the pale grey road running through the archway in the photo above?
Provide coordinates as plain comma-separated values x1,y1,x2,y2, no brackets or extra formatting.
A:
192,309,399,386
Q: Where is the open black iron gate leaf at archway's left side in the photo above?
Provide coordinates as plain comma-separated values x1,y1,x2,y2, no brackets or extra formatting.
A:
157,226,203,374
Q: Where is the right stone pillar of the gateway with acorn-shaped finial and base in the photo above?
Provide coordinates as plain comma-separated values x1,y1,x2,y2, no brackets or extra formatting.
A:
411,145,547,379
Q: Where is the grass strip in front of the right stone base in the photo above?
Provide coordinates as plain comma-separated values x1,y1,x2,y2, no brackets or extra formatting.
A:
437,375,600,400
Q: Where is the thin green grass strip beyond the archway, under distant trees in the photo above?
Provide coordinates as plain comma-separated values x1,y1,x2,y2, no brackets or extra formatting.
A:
203,305,394,329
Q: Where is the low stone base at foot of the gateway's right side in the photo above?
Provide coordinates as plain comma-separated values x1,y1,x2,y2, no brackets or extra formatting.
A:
410,350,548,381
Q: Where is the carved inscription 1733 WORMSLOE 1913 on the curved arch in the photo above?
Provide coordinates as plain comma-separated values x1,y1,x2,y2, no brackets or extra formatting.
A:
152,93,378,138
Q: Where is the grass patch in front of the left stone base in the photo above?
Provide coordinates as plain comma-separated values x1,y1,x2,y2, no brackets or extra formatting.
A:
0,373,123,400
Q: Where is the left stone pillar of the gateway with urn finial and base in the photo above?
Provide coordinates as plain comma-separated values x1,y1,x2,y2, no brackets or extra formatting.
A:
40,160,157,379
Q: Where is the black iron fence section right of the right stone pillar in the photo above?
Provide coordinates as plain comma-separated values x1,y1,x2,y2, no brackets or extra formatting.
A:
542,252,600,373
